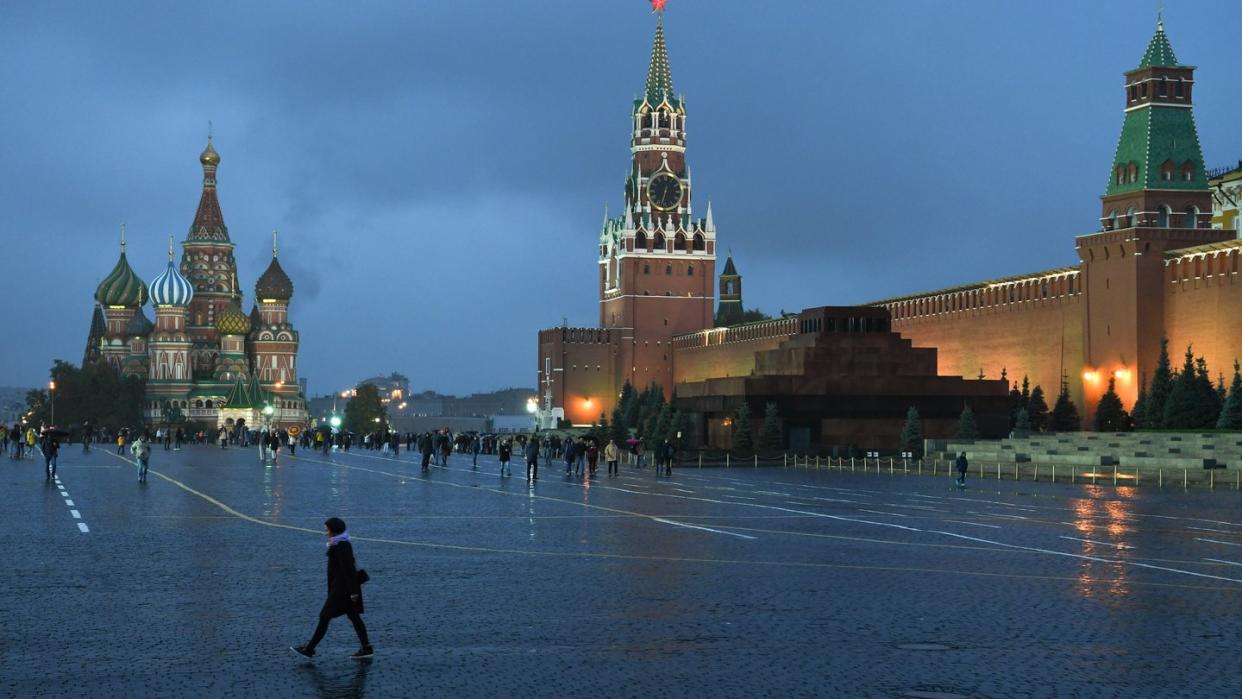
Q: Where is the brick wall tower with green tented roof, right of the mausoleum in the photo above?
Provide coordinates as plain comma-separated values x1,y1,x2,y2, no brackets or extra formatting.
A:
1077,20,1233,412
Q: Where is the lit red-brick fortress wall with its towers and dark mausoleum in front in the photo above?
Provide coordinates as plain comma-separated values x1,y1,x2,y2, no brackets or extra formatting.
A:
538,17,1242,451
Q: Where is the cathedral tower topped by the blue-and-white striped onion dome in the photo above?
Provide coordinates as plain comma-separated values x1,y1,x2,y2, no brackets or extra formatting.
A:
147,236,194,422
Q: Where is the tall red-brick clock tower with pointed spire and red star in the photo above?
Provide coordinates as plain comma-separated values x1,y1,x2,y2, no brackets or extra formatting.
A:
599,9,715,395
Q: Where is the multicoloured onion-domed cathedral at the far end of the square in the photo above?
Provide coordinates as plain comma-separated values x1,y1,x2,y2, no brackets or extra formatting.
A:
83,138,307,430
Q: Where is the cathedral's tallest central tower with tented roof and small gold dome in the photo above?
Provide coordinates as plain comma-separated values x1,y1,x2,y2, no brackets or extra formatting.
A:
181,135,241,377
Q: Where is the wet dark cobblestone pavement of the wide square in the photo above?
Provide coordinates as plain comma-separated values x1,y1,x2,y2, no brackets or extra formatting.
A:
7,447,1242,698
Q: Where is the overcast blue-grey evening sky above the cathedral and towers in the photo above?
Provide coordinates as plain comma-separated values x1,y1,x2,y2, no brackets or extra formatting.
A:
0,0,1242,391
